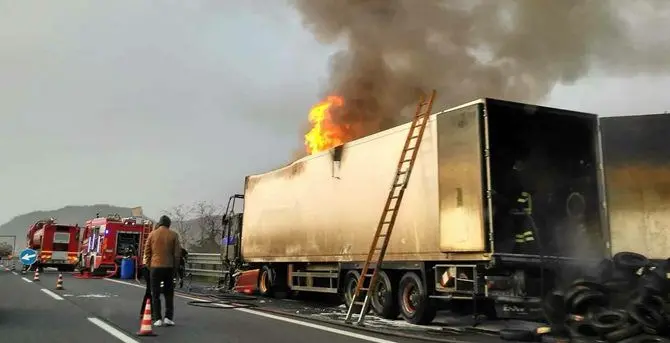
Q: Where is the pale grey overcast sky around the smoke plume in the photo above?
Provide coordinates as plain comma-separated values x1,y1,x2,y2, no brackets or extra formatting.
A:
0,0,670,222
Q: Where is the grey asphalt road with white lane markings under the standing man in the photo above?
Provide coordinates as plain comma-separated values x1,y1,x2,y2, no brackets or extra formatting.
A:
0,268,430,343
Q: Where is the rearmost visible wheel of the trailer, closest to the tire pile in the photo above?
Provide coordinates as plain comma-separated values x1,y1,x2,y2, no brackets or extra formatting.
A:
398,272,436,325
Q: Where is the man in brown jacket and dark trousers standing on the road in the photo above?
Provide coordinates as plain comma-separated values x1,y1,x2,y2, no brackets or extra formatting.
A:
144,216,181,326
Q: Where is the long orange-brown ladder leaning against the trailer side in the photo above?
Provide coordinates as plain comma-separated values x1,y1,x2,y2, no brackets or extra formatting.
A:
344,90,436,325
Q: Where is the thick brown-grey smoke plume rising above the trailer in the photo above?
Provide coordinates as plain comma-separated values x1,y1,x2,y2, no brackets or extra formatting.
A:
293,0,670,139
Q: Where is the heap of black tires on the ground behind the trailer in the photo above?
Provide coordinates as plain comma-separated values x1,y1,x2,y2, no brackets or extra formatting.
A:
542,252,670,343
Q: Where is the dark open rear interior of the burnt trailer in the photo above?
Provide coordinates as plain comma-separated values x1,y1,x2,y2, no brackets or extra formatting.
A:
486,99,609,258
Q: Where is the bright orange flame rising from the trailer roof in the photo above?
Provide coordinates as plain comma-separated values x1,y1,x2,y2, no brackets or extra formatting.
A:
305,95,345,154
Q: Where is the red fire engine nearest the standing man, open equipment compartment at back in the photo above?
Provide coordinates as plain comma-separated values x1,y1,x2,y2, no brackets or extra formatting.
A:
79,214,153,276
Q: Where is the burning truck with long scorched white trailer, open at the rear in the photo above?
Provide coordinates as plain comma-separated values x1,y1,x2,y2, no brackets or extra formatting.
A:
222,98,610,324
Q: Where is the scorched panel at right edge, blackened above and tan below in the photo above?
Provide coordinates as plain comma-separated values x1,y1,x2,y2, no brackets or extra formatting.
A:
601,114,670,258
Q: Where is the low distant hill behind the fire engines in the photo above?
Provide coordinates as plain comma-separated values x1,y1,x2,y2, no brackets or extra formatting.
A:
0,204,138,247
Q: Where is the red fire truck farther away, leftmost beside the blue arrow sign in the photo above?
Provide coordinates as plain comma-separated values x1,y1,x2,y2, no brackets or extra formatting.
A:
26,218,79,271
